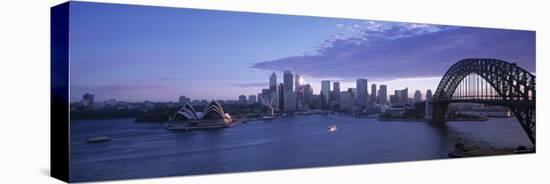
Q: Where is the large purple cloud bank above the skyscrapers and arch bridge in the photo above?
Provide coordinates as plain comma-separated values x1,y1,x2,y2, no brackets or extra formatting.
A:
252,21,535,80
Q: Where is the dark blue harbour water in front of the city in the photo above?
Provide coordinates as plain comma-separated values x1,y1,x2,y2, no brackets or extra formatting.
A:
70,115,531,182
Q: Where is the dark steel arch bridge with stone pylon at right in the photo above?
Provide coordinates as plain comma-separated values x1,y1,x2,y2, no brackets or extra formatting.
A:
430,58,536,145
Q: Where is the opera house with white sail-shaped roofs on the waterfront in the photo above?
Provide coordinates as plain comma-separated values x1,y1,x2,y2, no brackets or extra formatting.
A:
169,101,234,130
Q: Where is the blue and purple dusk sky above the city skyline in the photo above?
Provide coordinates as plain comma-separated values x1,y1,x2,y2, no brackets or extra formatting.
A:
70,2,535,102
